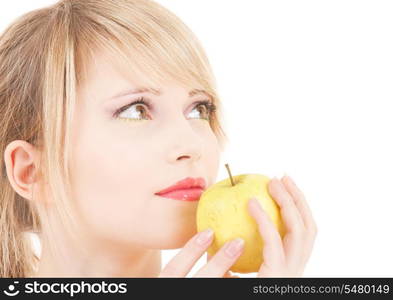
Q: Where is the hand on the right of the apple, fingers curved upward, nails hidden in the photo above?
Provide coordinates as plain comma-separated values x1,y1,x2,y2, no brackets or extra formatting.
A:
248,176,317,277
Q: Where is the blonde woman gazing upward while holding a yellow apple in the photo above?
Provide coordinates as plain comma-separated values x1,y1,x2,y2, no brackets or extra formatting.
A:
0,0,316,277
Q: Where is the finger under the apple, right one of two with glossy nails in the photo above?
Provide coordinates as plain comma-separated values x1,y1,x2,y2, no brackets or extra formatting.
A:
194,238,244,277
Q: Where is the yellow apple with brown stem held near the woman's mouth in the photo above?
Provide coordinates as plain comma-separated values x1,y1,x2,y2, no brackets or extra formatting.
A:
196,165,284,273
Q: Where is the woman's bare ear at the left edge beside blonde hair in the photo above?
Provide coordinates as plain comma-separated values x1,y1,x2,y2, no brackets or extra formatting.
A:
4,140,38,200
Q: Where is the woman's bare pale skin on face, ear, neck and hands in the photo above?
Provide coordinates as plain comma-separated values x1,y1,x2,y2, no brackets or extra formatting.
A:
4,48,317,277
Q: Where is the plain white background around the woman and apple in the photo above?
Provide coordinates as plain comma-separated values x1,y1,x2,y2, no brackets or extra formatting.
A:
0,0,393,277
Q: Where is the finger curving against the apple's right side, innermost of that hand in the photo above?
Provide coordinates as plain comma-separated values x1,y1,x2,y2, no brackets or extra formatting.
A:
248,198,285,270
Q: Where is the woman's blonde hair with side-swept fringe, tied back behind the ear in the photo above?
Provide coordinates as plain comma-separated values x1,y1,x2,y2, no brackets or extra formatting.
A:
0,0,227,277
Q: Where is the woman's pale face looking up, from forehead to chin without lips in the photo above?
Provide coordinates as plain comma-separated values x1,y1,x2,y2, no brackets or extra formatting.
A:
72,50,220,249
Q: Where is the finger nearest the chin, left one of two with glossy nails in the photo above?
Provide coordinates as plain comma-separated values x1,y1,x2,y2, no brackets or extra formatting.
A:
158,229,214,277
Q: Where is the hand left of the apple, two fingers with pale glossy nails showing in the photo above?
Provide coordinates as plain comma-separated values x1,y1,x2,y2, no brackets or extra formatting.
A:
158,230,244,277
